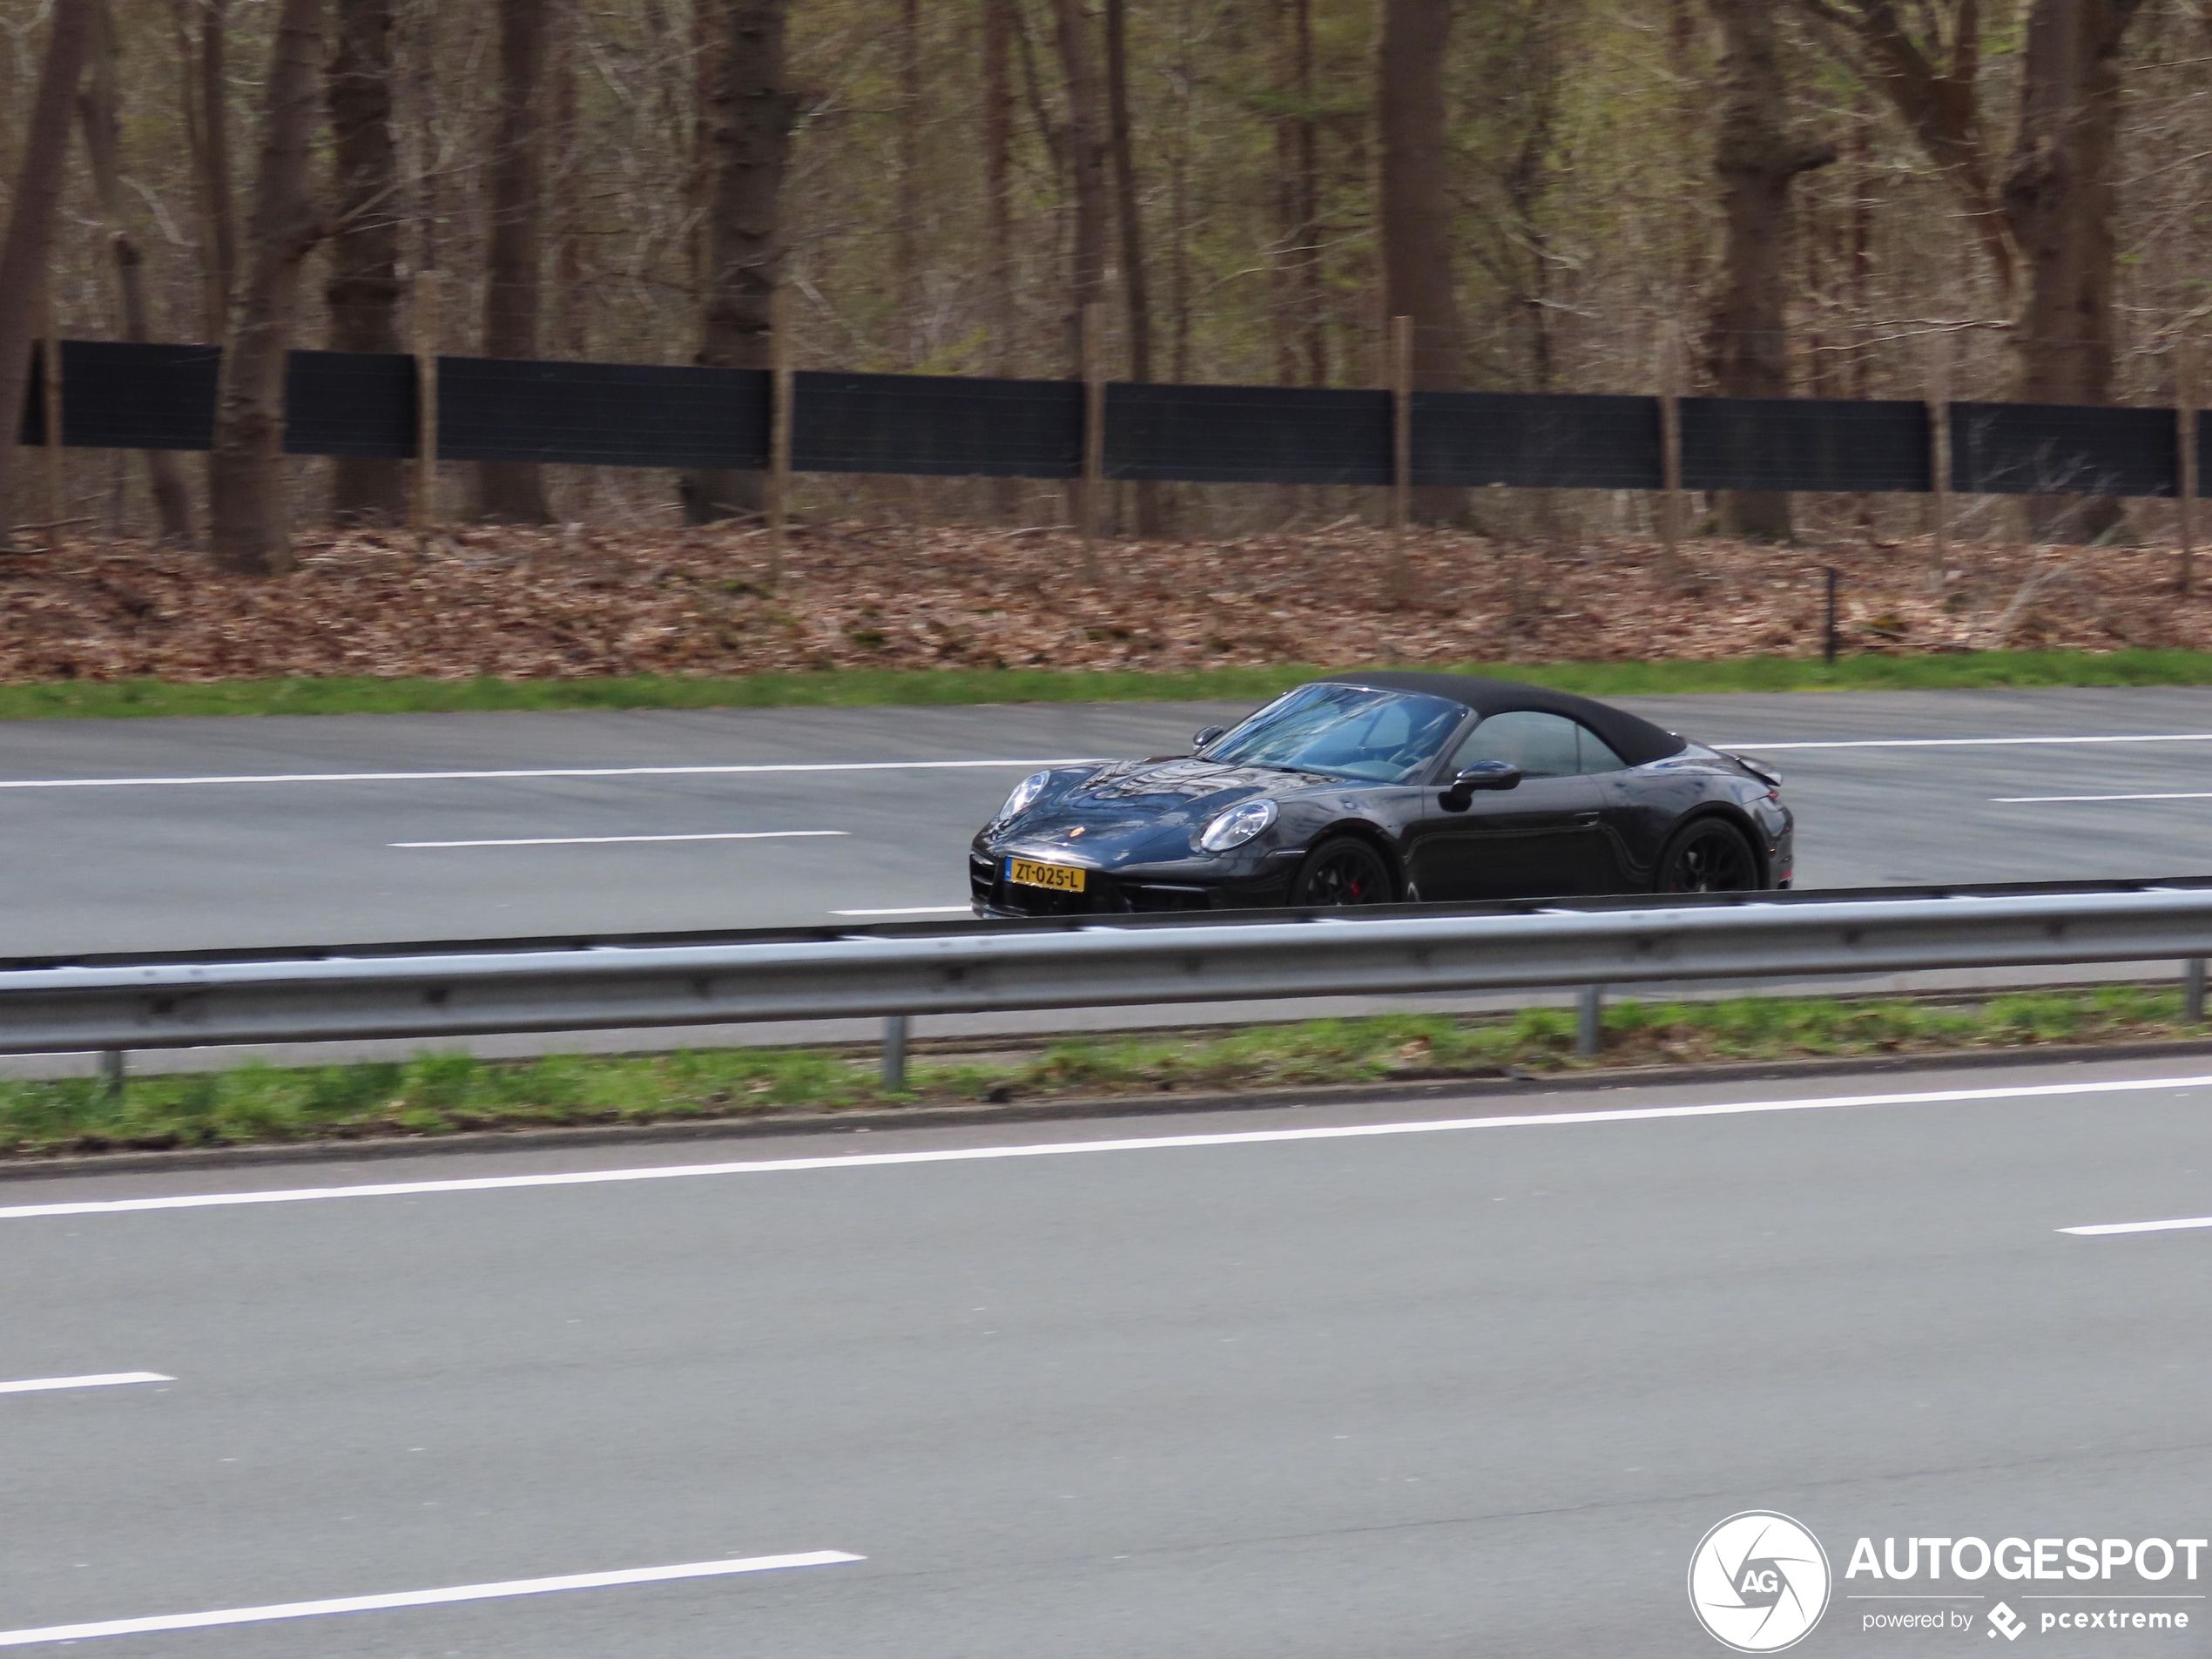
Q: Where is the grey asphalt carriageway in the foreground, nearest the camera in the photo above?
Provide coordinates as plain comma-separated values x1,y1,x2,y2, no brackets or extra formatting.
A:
0,1060,2212,1659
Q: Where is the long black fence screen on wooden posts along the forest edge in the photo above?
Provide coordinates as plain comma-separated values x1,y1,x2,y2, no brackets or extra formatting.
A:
20,341,2212,496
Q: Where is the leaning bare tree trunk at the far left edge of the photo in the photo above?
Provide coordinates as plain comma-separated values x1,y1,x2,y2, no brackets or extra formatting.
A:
0,0,95,550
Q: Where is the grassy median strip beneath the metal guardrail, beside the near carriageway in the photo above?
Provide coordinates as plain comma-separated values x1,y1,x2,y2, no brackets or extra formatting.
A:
0,984,2203,1157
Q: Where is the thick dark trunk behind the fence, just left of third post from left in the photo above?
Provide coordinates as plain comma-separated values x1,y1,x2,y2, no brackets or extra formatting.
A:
681,0,796,524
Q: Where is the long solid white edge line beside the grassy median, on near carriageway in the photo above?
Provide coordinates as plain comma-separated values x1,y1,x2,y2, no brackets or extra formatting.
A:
0,1075,2212,1221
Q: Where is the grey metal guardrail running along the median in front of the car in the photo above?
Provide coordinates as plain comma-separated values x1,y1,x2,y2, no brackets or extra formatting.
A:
0,880,2212,1070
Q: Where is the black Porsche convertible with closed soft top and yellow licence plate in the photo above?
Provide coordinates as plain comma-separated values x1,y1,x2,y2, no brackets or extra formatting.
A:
969,672,1791,916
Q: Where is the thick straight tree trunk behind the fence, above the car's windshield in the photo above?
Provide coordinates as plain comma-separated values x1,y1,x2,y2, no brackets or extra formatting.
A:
1376,0,1467,524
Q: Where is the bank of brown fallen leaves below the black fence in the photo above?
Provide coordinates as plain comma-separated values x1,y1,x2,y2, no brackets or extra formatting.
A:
0,524,2212,695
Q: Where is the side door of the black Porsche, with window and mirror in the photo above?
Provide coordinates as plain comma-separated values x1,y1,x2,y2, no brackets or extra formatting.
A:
1413,710,1613,902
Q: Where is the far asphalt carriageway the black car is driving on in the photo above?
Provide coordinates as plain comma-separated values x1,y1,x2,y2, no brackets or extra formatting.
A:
0,690,2212,955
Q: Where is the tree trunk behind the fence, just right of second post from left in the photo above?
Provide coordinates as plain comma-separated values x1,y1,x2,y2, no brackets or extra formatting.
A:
475,0,553,524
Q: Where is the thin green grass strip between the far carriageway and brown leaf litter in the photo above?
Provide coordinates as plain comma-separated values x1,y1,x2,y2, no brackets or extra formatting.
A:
12,651,2212,719
